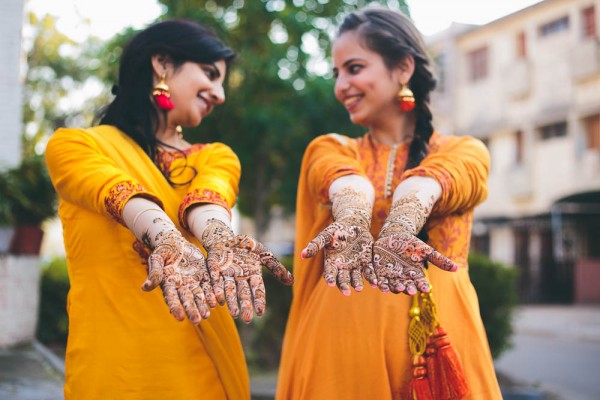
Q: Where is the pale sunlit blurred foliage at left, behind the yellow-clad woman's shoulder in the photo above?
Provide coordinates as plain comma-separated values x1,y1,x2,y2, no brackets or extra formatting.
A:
22,13,107,158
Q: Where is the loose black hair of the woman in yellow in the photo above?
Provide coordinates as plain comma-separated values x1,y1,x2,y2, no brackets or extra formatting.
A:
99,19,235,160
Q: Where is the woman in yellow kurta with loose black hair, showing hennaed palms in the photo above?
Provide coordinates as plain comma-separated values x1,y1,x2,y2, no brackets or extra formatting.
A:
46,20,291,400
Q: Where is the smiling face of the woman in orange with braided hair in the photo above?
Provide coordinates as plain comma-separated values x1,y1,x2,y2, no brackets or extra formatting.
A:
332,31,408,126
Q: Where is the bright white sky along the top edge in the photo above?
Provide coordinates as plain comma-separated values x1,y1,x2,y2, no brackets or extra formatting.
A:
25,0,540,41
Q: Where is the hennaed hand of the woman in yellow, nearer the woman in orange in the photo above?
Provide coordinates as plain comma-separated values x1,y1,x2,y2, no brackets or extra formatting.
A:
202,219,294,323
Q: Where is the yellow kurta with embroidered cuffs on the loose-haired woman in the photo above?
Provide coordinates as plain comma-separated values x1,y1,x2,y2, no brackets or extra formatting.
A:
46,126,250,400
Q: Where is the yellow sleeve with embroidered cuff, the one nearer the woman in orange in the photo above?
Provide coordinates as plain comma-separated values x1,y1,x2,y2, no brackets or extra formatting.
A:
179,143,242,230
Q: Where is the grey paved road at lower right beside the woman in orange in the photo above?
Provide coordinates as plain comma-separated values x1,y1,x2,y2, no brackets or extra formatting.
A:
495,305,600,400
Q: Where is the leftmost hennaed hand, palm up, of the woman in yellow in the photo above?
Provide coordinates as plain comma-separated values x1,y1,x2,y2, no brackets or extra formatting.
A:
142,230,217,325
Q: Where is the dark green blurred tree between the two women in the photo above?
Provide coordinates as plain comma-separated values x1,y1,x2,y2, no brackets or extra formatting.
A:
155,0,405,237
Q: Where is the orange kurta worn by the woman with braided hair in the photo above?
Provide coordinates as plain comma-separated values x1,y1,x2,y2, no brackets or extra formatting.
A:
277,133,501,400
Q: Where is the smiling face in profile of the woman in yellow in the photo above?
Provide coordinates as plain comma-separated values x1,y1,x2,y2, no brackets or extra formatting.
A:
157,60,227,127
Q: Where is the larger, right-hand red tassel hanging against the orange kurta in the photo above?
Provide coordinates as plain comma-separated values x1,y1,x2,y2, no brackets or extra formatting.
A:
428,326,469,400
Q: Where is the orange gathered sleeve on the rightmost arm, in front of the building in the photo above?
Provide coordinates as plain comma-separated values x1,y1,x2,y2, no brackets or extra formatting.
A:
403,136,490,215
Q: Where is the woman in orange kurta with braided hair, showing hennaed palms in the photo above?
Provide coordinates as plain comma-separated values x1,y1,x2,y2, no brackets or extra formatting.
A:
277,8,501,400
